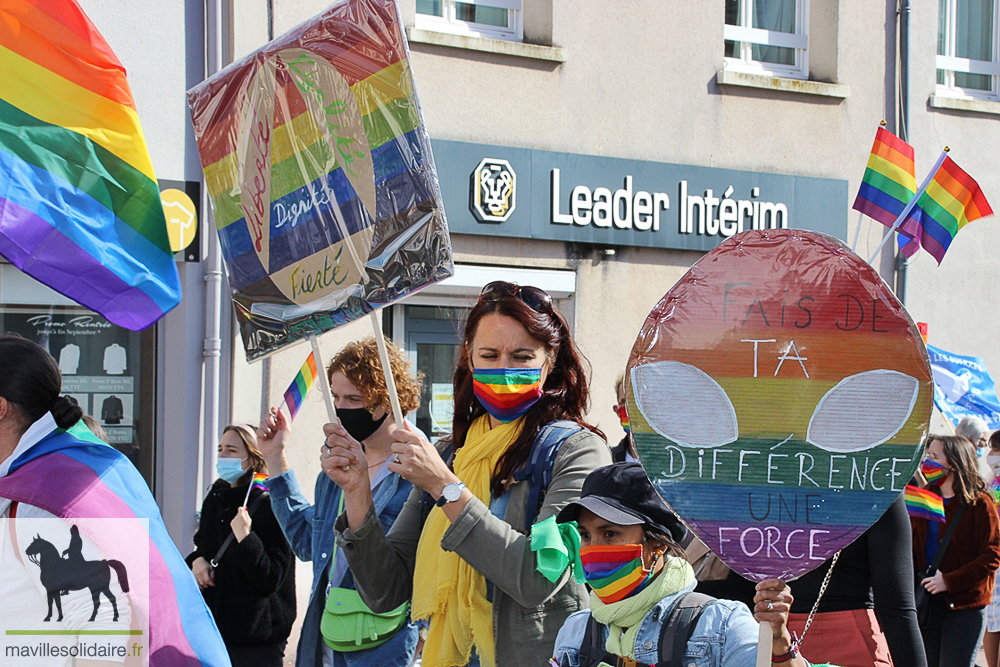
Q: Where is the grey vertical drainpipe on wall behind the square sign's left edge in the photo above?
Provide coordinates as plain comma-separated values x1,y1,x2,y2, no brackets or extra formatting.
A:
198,0,233,496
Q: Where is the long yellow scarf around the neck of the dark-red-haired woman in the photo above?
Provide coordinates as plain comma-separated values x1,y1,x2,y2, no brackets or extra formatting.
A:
412,415,522,667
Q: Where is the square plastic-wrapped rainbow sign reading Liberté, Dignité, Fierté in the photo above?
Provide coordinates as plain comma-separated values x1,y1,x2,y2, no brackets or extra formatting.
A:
188,0,453,360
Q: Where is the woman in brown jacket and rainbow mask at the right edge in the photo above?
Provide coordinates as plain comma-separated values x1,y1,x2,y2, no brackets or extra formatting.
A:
910,435,1000,667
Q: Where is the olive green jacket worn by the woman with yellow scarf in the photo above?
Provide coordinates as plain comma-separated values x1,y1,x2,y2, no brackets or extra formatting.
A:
335,429,611,667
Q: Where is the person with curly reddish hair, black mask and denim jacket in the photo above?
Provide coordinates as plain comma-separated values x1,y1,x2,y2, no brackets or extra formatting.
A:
257,336,420,667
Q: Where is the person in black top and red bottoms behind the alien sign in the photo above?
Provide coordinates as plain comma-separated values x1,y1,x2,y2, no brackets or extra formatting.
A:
788,494,927,667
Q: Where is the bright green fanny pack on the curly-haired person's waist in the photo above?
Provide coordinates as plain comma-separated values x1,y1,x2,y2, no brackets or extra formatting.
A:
319,588,410,652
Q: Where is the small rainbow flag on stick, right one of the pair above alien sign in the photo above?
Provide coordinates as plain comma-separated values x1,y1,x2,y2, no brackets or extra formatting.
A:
899,157,993,264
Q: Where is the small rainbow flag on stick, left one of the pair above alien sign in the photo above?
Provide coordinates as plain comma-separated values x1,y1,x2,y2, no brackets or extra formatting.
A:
854,127,917,232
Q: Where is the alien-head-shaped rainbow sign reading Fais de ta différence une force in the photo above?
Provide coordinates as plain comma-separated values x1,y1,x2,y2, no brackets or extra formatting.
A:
626,229,934,580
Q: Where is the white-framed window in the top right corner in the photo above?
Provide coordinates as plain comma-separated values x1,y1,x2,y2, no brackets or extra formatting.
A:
937,0,1000,100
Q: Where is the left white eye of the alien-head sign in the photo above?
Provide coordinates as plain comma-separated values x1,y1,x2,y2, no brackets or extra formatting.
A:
632,361,739,447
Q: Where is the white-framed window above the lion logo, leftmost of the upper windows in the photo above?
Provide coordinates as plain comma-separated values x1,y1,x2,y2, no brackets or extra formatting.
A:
416,0,524,41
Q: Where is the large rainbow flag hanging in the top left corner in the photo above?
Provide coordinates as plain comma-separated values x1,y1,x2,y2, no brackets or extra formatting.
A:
0,0,181,330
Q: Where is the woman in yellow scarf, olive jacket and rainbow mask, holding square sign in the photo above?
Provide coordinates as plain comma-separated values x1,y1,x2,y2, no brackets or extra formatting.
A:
325,281,611,667
